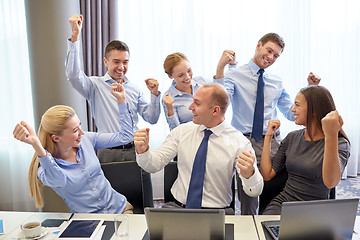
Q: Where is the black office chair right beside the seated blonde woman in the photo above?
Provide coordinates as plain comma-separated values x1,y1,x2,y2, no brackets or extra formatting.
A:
101,161,154,214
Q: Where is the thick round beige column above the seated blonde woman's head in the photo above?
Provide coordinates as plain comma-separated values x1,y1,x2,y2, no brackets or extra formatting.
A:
25,0,87,130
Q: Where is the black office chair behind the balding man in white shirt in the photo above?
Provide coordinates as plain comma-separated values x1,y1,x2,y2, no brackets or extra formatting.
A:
164,161,235,213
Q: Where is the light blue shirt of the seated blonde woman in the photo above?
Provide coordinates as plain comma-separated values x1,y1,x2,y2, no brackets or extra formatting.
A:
37,104,133,213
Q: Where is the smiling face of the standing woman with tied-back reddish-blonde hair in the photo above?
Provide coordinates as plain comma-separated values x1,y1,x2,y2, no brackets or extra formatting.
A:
169,59,193,92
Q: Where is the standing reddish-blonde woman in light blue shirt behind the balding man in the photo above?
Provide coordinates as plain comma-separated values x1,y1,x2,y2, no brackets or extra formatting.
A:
162,50,236,130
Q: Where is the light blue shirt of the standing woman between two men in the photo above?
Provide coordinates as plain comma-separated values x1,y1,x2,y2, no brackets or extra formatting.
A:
162,76,211,131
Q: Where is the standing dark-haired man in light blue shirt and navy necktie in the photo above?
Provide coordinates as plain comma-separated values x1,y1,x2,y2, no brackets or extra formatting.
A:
214,33,320,215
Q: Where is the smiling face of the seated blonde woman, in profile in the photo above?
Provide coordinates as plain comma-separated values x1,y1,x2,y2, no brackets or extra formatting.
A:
56,115,84,148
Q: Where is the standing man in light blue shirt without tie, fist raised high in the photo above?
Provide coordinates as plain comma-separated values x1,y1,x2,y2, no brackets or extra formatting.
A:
65,15,160,162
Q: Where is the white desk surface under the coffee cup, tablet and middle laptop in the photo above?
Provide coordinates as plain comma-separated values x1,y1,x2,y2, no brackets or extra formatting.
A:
0,211,258,240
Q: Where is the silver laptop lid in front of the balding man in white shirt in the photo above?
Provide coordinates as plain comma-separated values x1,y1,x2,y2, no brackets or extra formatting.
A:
145,208,225,240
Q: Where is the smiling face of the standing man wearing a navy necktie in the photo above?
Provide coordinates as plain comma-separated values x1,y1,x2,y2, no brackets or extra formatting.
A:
252,41,283,69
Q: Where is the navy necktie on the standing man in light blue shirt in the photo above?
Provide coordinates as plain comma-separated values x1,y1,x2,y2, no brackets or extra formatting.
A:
251,68,264,142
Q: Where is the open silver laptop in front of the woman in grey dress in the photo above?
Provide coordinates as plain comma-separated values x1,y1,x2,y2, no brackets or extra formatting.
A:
261,198,359,240
